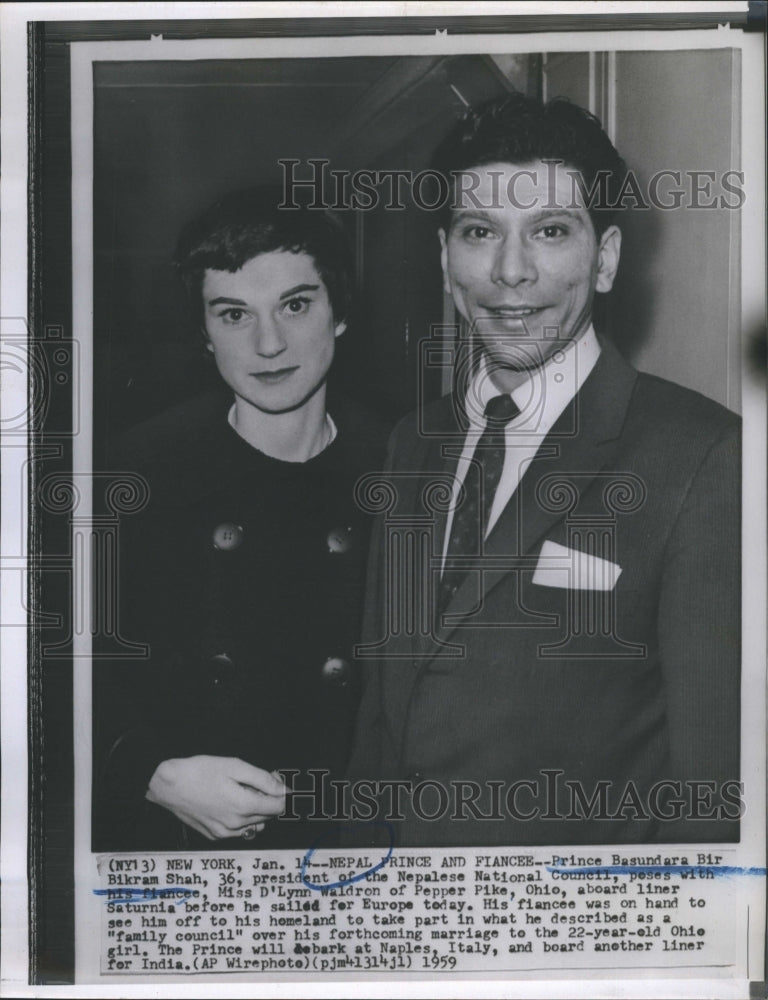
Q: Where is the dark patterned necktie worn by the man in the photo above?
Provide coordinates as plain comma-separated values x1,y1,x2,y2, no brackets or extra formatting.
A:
437,395,520,613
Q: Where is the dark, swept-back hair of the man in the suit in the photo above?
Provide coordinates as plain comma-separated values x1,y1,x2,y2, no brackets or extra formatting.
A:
433,94,627,238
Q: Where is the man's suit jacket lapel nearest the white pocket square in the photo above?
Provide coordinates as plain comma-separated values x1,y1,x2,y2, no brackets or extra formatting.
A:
423,344,637,664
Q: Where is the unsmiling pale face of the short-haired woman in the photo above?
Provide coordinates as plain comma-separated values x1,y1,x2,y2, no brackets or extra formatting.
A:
202,250,345,413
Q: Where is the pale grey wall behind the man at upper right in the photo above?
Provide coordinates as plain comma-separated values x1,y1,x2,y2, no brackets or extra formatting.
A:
543,49,741,410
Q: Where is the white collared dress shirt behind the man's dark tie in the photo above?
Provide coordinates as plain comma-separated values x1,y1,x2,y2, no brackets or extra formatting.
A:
443,325,600,566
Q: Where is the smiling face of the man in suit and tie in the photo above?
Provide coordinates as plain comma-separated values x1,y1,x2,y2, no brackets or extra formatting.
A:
440,161,621,391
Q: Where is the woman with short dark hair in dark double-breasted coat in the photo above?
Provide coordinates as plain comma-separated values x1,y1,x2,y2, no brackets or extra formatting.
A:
95,189,383,850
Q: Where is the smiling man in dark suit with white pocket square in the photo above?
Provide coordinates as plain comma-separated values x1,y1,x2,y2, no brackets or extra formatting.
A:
350,95,740,846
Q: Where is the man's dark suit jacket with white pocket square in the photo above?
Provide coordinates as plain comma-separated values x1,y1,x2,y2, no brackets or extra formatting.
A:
350,345,740,845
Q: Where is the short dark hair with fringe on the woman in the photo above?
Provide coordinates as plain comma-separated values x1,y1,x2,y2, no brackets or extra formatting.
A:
174,186,354,323
